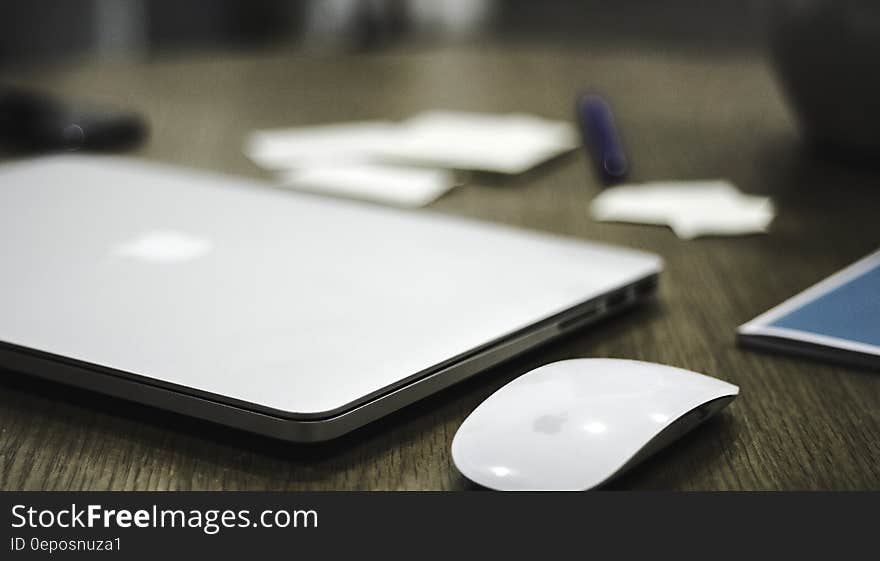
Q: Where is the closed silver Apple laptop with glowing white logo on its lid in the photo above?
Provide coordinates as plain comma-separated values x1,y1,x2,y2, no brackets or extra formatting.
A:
0,156,661,441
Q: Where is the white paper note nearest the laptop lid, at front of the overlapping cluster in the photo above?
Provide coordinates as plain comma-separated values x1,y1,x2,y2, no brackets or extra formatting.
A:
279,163,456,207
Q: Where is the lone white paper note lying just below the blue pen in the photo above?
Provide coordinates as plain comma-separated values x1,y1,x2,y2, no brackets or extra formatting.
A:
590,180,775,239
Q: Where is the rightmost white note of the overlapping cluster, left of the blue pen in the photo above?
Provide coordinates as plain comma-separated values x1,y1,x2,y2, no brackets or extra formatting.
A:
375,111,580,174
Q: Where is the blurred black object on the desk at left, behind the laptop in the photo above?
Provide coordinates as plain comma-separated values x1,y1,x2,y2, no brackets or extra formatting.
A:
0,88,147,152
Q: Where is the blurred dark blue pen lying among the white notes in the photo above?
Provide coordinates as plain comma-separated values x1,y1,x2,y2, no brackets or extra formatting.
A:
577,93,629,184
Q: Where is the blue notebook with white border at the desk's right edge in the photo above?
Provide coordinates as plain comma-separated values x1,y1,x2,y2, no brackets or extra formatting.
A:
737,251,880,368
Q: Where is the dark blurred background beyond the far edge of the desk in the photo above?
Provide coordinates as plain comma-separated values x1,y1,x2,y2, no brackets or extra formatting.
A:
0,0,761,67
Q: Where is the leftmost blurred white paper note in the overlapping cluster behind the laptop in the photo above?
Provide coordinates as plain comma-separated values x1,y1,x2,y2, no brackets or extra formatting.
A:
244,121,400,170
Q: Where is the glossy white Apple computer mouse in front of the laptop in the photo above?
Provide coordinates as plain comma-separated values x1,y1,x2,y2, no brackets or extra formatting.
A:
452,358,739,491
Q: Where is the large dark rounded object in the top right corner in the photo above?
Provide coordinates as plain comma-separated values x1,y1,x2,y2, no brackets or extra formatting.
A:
769,0,880,165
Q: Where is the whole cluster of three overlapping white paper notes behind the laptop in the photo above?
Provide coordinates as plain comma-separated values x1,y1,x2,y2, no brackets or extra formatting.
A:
244,111,578,206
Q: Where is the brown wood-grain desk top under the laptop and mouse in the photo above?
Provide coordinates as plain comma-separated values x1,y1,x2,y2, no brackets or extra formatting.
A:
0,45,880,490
